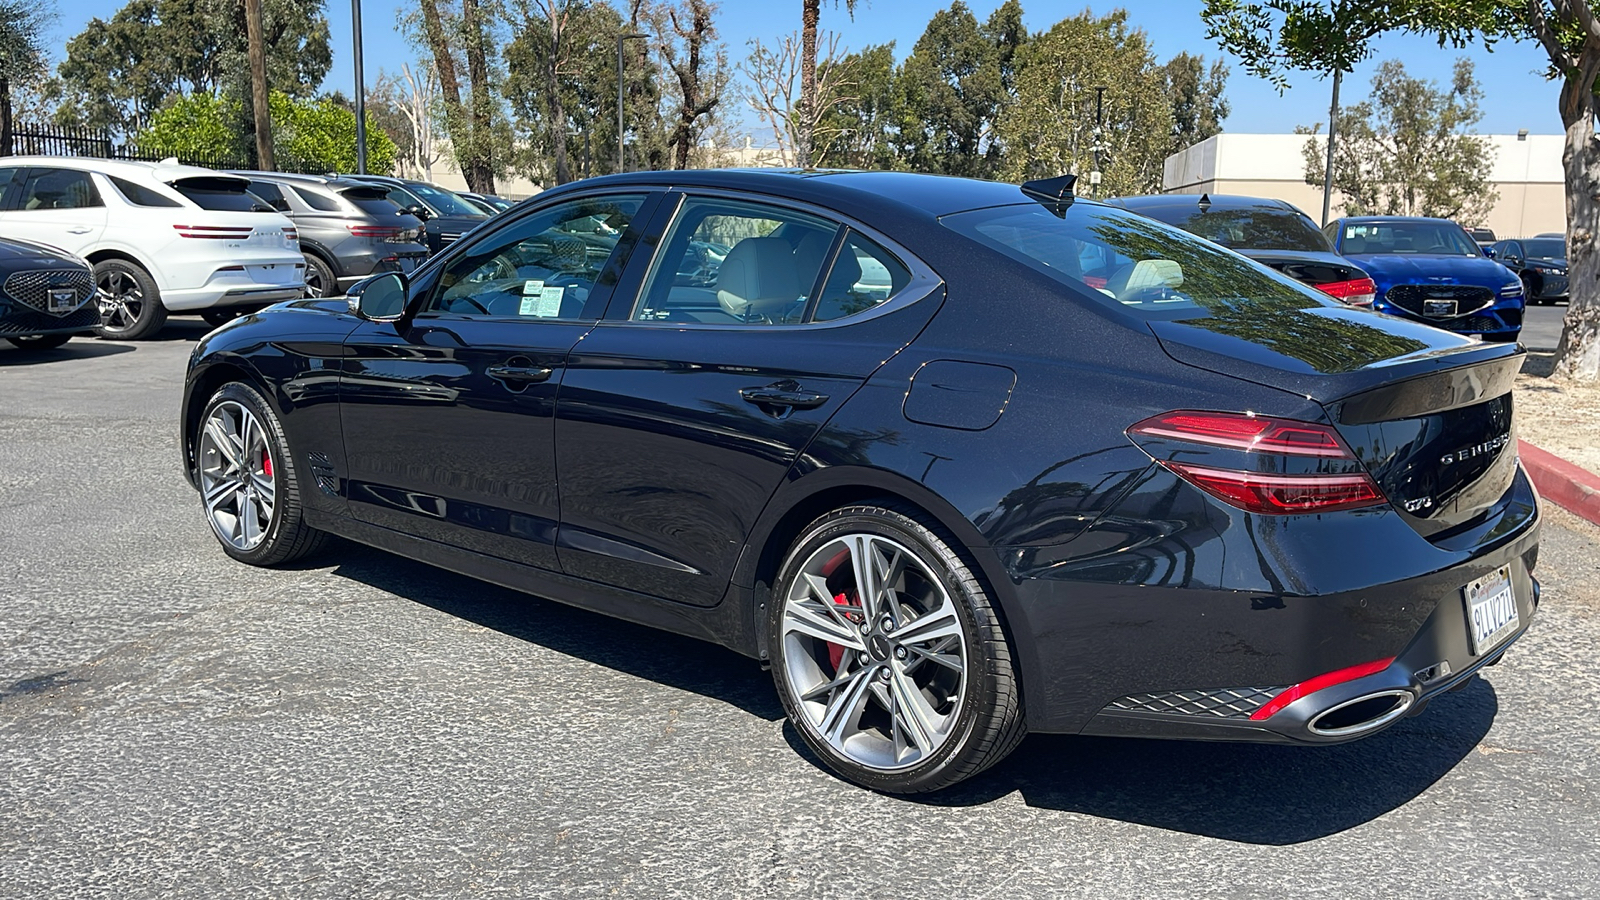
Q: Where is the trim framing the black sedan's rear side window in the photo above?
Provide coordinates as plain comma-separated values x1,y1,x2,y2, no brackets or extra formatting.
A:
600,187,944,331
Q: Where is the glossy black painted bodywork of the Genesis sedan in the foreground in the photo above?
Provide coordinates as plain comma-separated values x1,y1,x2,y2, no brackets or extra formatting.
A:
182,171,1538,740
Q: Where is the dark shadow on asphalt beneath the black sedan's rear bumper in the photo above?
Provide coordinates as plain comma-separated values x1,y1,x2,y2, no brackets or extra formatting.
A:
902,677,1499,844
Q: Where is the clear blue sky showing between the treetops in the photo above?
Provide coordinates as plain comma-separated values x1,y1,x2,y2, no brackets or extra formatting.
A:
53,0,1562,144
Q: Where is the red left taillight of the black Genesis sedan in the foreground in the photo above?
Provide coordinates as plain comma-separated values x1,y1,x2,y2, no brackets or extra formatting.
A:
1128,410,1387,516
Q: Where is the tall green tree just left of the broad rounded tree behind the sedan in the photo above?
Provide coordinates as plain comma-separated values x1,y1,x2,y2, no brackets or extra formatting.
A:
896,0,1030,178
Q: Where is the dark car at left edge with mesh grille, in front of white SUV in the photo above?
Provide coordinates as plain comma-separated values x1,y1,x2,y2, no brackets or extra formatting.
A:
0,237,99,351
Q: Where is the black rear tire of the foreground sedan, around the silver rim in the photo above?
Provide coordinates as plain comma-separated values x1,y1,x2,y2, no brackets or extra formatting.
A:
766,501,1026,794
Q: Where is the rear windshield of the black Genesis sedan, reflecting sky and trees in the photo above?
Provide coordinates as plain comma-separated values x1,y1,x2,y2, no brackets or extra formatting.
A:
941,203,1338,319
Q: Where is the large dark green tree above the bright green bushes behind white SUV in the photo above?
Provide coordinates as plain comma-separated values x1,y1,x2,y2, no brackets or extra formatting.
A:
58,0,333,133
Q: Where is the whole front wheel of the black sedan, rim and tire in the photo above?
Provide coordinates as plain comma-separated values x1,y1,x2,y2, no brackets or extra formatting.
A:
195,383,326,565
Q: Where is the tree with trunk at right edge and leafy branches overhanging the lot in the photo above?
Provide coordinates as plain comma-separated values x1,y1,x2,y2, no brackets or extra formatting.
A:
1202,0,1600,381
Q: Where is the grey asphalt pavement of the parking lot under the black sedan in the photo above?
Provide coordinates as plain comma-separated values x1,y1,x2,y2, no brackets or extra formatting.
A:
0,318,1600,900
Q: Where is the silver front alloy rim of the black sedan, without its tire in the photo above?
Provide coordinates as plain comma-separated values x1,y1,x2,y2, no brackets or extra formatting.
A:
200,400,277,551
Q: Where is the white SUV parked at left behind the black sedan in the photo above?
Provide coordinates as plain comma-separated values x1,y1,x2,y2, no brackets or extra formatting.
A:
0,157,306,340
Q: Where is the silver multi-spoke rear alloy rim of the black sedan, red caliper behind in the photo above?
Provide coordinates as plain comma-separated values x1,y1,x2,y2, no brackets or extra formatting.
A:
779,533,966,770
